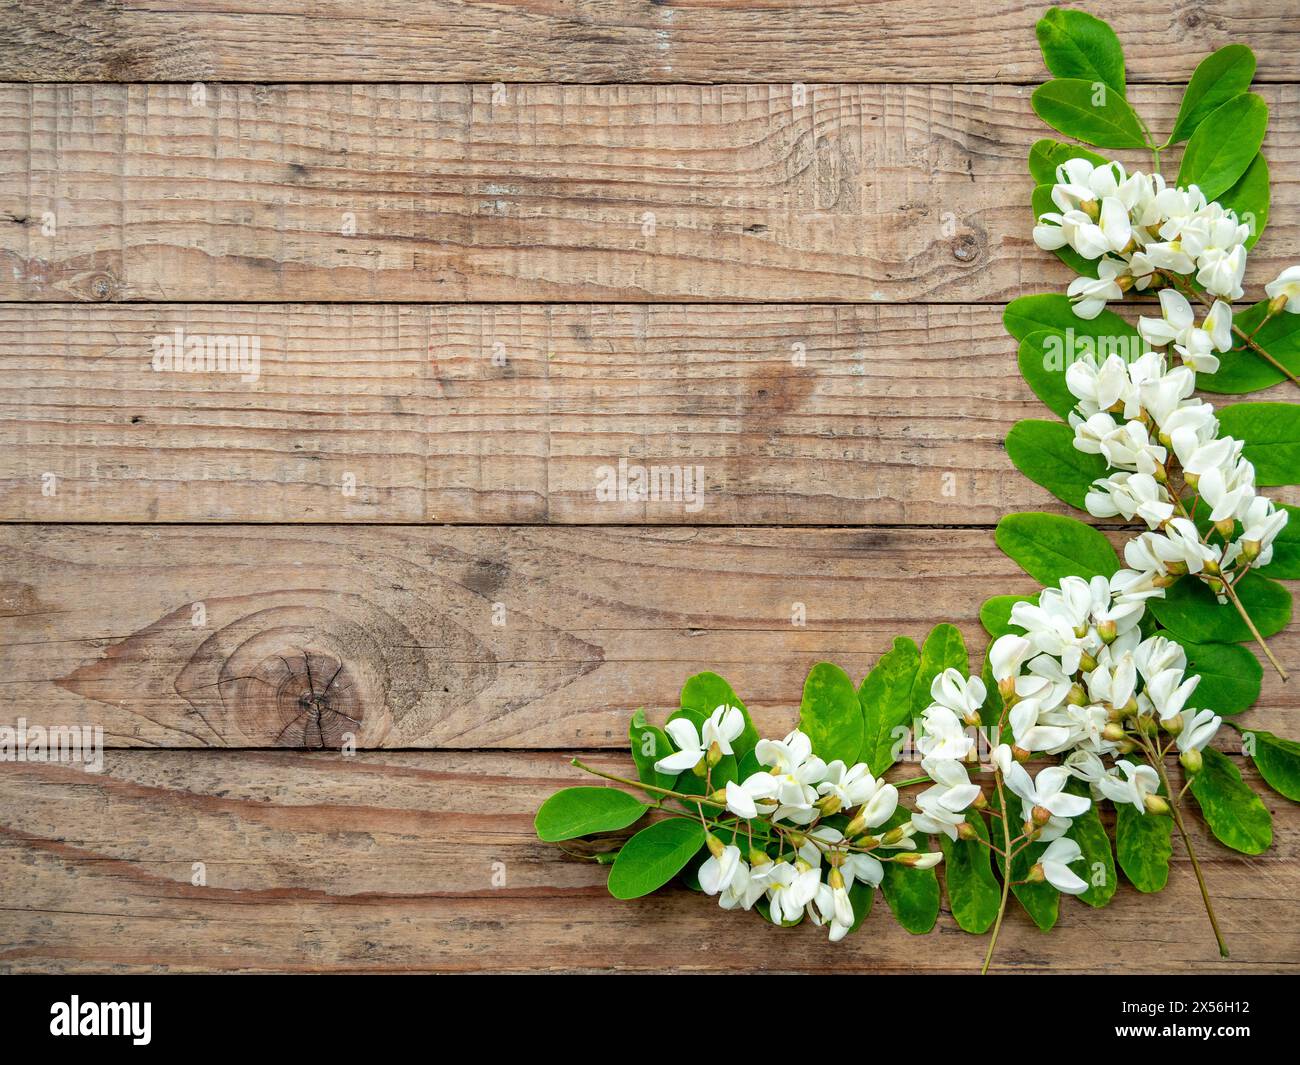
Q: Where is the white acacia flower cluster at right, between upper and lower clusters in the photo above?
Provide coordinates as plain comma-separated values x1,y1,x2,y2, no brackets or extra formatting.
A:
1065,340,1288,602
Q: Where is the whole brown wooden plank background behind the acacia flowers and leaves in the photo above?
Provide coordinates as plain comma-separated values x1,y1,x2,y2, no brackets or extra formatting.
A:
0,0,1300,973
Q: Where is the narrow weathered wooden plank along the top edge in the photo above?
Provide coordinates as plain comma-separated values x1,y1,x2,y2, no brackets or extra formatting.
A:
0,0,1300,82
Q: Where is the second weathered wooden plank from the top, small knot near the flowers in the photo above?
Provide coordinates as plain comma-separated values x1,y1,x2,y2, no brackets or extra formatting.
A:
0,85,1300,302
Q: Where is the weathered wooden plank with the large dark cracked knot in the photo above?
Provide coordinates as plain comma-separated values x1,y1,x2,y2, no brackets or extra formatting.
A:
0,525,1300,748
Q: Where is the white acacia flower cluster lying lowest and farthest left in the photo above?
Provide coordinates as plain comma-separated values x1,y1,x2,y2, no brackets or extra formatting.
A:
655,707,941,943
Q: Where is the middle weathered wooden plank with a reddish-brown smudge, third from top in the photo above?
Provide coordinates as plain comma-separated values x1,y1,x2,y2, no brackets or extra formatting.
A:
0,304,1291,525
